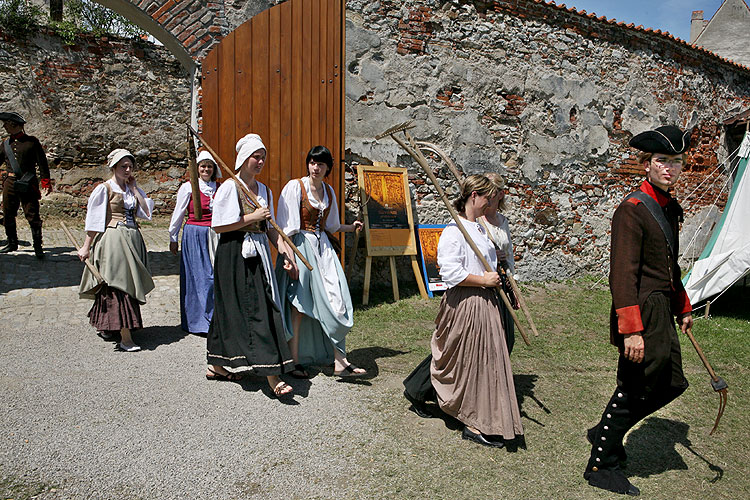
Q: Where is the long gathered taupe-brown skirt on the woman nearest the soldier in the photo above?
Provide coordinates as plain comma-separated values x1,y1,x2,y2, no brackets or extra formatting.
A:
430,286,523,439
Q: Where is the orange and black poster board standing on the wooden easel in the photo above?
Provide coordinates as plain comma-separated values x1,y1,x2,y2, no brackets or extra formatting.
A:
357,163,417,257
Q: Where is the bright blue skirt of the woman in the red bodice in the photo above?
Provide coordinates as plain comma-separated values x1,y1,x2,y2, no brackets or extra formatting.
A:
180,224,214,333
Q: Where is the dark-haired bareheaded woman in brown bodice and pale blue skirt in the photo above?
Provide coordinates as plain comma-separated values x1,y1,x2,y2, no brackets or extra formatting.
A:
276,146,366,378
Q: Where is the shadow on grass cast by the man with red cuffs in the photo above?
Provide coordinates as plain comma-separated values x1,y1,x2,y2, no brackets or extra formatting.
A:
625,417,724,483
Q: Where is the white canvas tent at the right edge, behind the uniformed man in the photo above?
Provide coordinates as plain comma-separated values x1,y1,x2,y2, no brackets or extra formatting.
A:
683,133,750,305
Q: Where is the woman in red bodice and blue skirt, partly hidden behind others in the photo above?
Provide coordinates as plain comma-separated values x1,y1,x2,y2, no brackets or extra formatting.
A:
169,151,221,335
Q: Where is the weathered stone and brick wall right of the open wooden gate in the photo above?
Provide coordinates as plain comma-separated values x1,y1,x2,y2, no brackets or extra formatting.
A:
346,0,750,280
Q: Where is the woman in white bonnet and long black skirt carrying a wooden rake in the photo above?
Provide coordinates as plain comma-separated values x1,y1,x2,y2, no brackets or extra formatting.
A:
206,134,298,397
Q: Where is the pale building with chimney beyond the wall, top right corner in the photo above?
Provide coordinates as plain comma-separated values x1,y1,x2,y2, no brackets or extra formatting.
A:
690,0,750,66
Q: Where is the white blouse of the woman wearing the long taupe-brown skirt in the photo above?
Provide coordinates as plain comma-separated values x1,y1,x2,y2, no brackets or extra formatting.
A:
438,218,497,288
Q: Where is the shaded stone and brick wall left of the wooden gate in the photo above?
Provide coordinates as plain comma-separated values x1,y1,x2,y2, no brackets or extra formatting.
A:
0,28,190,216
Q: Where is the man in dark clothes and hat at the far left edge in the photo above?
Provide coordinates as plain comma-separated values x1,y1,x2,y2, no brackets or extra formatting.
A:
0,112,52,259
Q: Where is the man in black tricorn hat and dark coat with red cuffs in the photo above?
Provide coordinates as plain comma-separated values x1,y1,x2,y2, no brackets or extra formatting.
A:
583,126,693,496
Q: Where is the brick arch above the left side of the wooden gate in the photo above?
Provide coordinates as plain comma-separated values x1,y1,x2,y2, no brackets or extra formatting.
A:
95,0,229,77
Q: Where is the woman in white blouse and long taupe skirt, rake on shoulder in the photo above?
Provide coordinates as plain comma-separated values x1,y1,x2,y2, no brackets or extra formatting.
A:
430,175,523,447
